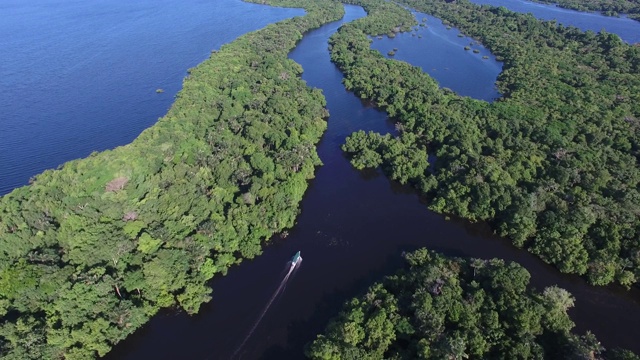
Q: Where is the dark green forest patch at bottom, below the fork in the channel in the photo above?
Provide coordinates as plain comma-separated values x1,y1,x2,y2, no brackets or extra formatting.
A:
306,249,640,360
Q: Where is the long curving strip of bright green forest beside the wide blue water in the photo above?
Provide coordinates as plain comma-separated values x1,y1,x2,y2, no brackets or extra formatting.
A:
0,0,344,360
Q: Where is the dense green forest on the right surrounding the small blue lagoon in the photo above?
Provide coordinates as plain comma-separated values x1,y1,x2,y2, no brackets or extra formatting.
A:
331,0,640,286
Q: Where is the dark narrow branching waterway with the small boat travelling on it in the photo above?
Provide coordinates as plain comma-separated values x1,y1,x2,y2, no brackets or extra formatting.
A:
108,6,640,359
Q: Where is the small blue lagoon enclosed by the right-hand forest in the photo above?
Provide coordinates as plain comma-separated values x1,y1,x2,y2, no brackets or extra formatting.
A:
371,12,502,101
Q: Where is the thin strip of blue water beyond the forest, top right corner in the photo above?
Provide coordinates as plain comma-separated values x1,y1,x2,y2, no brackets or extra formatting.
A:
470,0,640,44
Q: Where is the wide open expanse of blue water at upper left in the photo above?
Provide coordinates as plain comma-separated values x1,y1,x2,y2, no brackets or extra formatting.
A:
0,0,304,195
